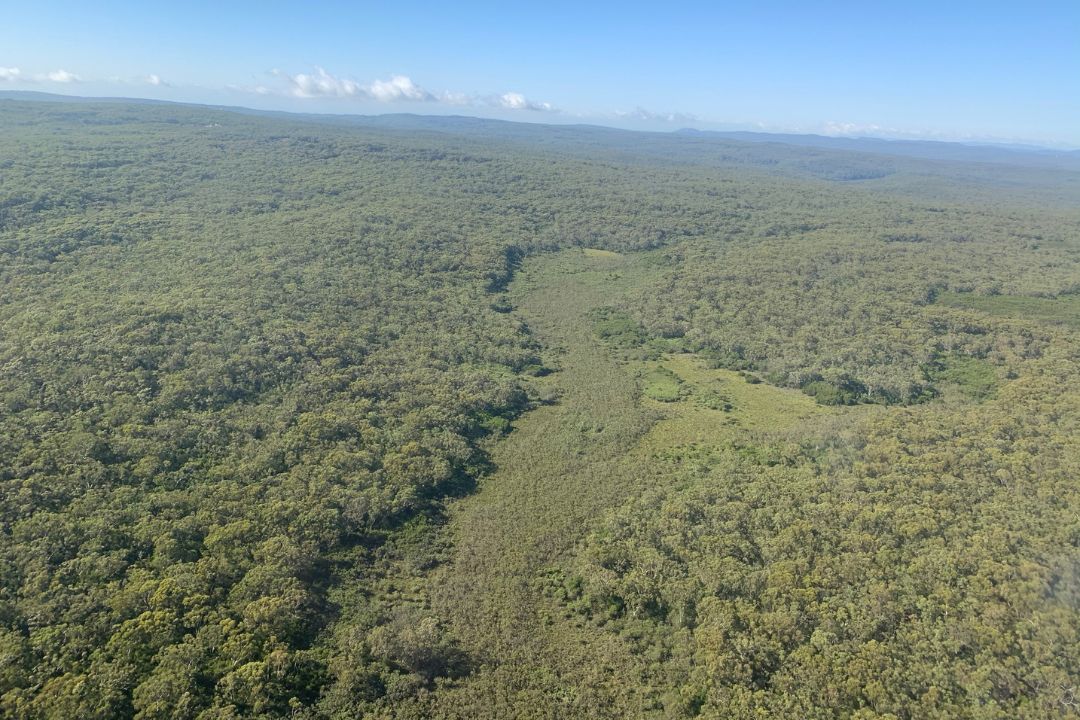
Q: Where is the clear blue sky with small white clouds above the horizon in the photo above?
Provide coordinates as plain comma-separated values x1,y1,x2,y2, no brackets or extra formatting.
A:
0,0,1080,147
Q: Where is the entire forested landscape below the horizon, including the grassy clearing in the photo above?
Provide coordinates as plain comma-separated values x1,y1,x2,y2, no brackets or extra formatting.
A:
0,99,1080,720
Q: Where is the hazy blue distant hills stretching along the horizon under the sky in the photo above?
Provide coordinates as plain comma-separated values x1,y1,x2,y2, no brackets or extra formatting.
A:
6,91,1080,197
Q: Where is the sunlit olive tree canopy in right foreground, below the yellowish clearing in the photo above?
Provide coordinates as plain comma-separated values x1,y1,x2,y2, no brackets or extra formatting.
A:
570,357,1080,718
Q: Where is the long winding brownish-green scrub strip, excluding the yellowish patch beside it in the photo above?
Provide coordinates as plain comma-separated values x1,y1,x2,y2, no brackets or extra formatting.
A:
412,252,659,717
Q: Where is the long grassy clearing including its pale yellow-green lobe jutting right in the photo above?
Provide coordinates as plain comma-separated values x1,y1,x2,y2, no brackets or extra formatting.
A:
410,252,851,718
